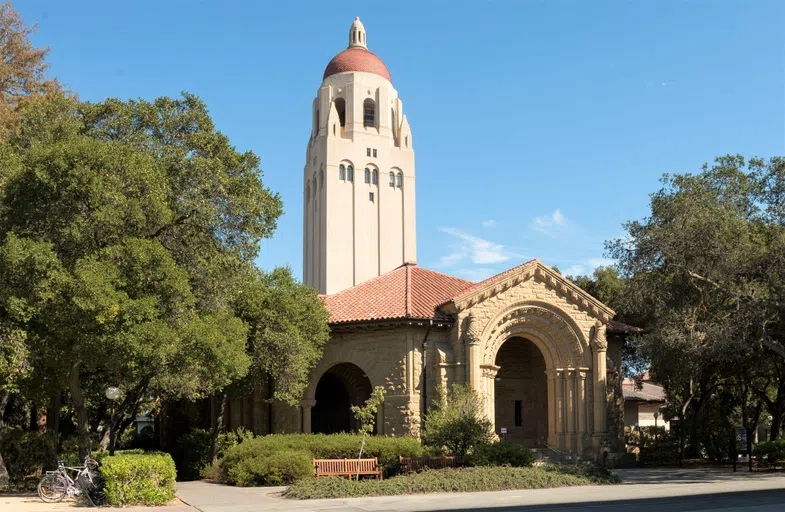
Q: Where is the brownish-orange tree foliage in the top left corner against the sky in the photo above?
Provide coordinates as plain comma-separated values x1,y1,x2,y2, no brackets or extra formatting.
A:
0,2,60,136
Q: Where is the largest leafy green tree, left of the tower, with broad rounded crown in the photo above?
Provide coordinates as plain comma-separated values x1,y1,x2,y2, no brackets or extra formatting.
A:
0,94,281,455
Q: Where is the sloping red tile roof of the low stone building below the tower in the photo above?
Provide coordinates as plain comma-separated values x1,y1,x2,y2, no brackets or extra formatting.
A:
324,263,473,323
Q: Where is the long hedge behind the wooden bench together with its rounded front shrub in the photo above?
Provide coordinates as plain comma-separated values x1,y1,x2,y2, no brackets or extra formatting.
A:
214,434,422,485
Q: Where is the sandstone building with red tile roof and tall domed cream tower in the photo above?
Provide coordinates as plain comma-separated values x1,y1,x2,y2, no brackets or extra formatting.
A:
213,19,631,456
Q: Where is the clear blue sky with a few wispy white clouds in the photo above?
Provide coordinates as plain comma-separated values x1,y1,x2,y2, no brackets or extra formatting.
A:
14,0,785,279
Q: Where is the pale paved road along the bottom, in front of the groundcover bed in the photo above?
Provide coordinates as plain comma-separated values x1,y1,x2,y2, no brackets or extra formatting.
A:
178,469,785,512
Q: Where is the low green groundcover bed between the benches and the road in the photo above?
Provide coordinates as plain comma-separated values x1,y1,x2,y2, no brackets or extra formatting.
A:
283,465,621,500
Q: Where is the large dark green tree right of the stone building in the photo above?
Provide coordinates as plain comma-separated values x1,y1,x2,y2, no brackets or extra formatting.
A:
608,155,785,454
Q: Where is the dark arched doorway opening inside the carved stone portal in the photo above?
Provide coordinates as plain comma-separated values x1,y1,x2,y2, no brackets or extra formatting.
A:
494,336,548,447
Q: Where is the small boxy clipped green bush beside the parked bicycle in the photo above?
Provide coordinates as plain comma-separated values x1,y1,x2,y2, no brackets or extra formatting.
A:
101,452,177,506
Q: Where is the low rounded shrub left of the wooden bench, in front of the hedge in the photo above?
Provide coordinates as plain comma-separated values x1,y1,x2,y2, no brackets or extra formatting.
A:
227,450,313,487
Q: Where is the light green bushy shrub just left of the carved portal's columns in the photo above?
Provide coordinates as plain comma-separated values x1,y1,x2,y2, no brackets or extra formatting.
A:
422,385,493,457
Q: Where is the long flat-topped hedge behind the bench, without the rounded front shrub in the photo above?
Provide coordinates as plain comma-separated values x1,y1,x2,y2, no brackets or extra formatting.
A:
217,434,422,482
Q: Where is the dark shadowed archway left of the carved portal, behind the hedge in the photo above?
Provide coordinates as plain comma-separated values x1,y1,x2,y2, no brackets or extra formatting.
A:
311,363,371,434
